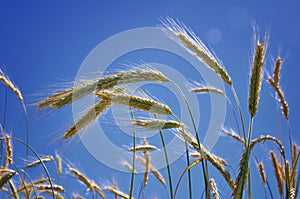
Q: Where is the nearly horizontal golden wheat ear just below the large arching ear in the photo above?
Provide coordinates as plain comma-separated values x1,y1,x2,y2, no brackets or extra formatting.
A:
96,91,172,115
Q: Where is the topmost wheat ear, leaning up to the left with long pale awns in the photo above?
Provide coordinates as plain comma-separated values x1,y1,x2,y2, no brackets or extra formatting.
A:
162,18,232,85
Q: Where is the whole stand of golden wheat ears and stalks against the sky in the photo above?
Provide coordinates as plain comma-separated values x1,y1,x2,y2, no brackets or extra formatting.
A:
0,18,300,199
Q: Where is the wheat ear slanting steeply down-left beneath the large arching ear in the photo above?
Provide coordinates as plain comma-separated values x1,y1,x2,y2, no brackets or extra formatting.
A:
64,99,111,140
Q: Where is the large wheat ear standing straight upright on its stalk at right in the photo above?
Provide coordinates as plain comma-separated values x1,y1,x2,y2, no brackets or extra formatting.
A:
248,42,267,117
